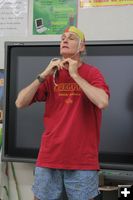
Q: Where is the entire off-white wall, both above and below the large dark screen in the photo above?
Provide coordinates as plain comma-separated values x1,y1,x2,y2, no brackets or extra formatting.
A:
0,0,133,200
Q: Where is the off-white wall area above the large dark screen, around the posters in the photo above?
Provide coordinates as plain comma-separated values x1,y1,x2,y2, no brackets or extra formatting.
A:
0,0,133,68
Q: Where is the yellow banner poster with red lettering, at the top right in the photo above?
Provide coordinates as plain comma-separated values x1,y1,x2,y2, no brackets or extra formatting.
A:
80,0,133,8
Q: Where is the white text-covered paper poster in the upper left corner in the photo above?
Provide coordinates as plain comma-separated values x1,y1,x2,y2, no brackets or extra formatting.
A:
0,0,28,37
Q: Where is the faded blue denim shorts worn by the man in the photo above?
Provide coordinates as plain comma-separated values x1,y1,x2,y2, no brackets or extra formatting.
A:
32,167,99,200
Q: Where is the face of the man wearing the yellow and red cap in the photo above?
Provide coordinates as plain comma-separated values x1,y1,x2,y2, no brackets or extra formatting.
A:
60,32,80,58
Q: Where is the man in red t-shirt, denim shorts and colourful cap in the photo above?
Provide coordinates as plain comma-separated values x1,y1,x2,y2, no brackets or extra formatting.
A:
16,26,109,200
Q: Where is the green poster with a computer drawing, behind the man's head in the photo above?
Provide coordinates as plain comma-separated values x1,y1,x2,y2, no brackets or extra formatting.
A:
33,0,78,35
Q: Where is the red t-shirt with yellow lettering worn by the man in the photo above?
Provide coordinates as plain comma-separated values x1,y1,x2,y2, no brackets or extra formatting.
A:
32,64,109,170
